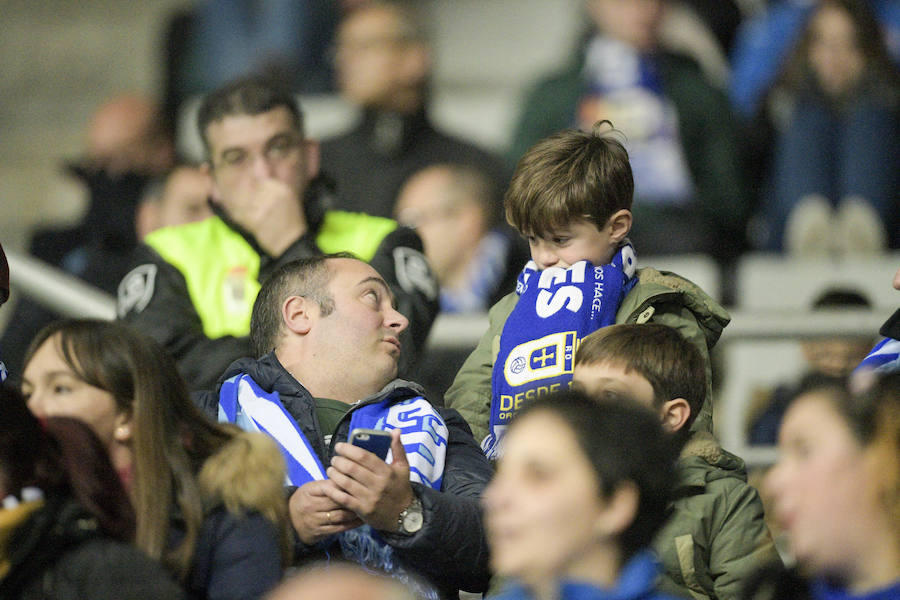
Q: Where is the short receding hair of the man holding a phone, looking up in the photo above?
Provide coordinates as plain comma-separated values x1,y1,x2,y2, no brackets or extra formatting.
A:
250,252,357,358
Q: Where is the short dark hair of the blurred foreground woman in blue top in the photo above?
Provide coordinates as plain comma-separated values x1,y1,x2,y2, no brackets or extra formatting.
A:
511,390,677,559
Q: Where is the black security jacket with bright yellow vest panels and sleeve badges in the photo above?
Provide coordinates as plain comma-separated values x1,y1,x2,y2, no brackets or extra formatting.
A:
117,204,438,389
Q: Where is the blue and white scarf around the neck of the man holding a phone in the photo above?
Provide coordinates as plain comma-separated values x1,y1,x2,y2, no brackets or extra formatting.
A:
219,373,450,598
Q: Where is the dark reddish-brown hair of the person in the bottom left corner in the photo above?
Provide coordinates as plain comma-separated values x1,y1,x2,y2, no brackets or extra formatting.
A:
0,385,136,542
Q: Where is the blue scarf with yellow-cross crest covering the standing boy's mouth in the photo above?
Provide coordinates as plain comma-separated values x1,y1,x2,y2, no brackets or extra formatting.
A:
481,243,637,460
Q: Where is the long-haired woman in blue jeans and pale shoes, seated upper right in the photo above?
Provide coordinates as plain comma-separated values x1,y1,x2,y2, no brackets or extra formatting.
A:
765,0,900,253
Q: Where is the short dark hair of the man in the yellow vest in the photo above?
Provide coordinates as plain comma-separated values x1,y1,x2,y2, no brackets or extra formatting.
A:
197,77,303,156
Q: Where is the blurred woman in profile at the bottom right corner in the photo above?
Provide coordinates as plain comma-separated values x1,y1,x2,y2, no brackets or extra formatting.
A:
765,373,900,600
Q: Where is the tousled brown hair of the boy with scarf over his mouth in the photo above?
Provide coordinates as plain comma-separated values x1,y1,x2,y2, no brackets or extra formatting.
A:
503,121,634,237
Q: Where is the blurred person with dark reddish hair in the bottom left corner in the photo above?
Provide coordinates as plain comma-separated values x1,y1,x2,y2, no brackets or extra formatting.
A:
0,387,185,600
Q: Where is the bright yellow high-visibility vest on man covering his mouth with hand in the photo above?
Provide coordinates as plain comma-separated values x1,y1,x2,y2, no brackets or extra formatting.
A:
144,211,397,338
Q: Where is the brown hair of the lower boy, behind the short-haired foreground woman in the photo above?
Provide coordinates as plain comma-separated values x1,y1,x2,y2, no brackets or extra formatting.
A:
575,323,706,432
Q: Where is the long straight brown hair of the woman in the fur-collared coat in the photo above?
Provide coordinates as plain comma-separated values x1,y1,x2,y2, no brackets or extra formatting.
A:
25,320,233,578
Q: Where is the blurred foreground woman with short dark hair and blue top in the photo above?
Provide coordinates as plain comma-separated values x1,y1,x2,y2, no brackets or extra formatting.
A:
484,392,675,600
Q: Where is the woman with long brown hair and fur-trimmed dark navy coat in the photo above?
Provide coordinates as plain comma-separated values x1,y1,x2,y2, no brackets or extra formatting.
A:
22,320,288,599
